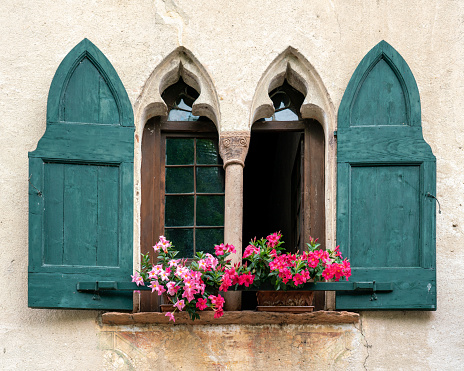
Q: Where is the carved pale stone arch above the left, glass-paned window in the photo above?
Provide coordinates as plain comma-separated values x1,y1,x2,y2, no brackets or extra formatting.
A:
135,46,220,135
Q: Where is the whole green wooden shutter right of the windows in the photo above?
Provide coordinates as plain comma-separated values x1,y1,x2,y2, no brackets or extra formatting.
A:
336,41,436,310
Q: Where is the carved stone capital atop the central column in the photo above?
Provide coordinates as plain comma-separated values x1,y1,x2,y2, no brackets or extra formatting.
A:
219,131,250,169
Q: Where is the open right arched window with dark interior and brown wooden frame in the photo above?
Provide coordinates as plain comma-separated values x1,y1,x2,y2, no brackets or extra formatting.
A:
243,80,325,252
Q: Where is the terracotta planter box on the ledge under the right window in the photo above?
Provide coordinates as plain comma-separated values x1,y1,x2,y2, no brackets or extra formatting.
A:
256,291,314,313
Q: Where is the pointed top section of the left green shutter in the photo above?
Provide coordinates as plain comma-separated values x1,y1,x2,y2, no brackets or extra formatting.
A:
47,39,134,126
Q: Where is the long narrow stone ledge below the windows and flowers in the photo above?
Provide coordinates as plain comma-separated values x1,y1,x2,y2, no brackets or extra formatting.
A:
102,311,359,325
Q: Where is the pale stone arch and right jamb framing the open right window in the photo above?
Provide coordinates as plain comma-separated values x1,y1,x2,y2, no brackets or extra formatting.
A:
249,47,336,253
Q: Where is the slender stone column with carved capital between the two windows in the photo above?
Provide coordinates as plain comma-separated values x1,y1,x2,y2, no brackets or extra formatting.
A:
219,132,250,310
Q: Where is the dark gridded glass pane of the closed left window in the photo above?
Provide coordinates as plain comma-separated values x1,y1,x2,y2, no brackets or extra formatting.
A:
164,137,225,257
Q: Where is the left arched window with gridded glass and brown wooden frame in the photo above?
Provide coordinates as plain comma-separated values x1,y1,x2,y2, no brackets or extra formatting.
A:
141,78,224,258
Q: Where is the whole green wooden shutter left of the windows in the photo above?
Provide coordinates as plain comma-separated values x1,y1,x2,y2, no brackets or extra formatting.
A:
28,39,134,310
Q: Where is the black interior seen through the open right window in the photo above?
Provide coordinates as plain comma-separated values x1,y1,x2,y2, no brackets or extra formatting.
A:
243,131,303,252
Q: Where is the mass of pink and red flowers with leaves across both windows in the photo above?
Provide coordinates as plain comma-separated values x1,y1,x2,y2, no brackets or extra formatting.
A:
132,232,351,322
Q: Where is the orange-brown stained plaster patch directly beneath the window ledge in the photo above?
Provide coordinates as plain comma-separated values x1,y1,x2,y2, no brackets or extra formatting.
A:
100,325,365,371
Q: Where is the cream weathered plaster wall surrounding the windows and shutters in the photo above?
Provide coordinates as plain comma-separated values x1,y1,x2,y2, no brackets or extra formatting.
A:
0,0,464,370
